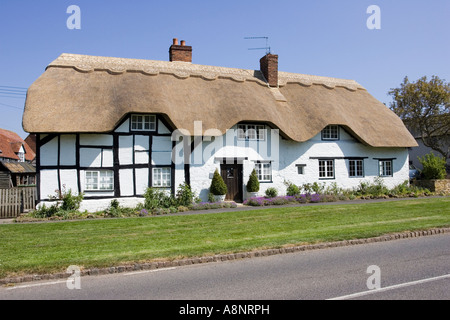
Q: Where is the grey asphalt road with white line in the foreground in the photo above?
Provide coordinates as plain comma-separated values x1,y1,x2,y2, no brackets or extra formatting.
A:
0,234,450,303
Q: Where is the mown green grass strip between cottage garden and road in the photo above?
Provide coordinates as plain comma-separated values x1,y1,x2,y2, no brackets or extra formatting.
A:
0,197,450,278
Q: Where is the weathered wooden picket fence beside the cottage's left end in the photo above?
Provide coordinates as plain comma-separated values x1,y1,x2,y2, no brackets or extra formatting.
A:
0,187,37,219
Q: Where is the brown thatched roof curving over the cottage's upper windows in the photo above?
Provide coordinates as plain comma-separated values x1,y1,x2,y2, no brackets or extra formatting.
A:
23,54,417,147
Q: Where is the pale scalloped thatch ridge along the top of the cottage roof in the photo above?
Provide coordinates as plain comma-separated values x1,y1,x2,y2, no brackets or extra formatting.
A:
47,53,364,91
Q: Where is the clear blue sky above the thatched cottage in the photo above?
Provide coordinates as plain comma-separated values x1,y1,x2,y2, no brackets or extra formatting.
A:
0,0,450,138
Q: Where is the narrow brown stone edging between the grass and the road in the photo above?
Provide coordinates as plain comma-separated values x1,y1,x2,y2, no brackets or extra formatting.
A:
0,227,450,285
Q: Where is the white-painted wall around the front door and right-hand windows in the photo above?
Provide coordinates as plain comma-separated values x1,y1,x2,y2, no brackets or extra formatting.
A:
190,126,409,200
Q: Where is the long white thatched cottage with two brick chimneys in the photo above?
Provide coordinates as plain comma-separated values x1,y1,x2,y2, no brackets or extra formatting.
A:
23,39,417,208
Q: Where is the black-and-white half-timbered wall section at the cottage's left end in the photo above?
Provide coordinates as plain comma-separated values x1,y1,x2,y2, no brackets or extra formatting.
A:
37,116,176,200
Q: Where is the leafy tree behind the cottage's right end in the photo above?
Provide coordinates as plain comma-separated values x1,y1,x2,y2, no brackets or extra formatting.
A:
388,76,450,158
